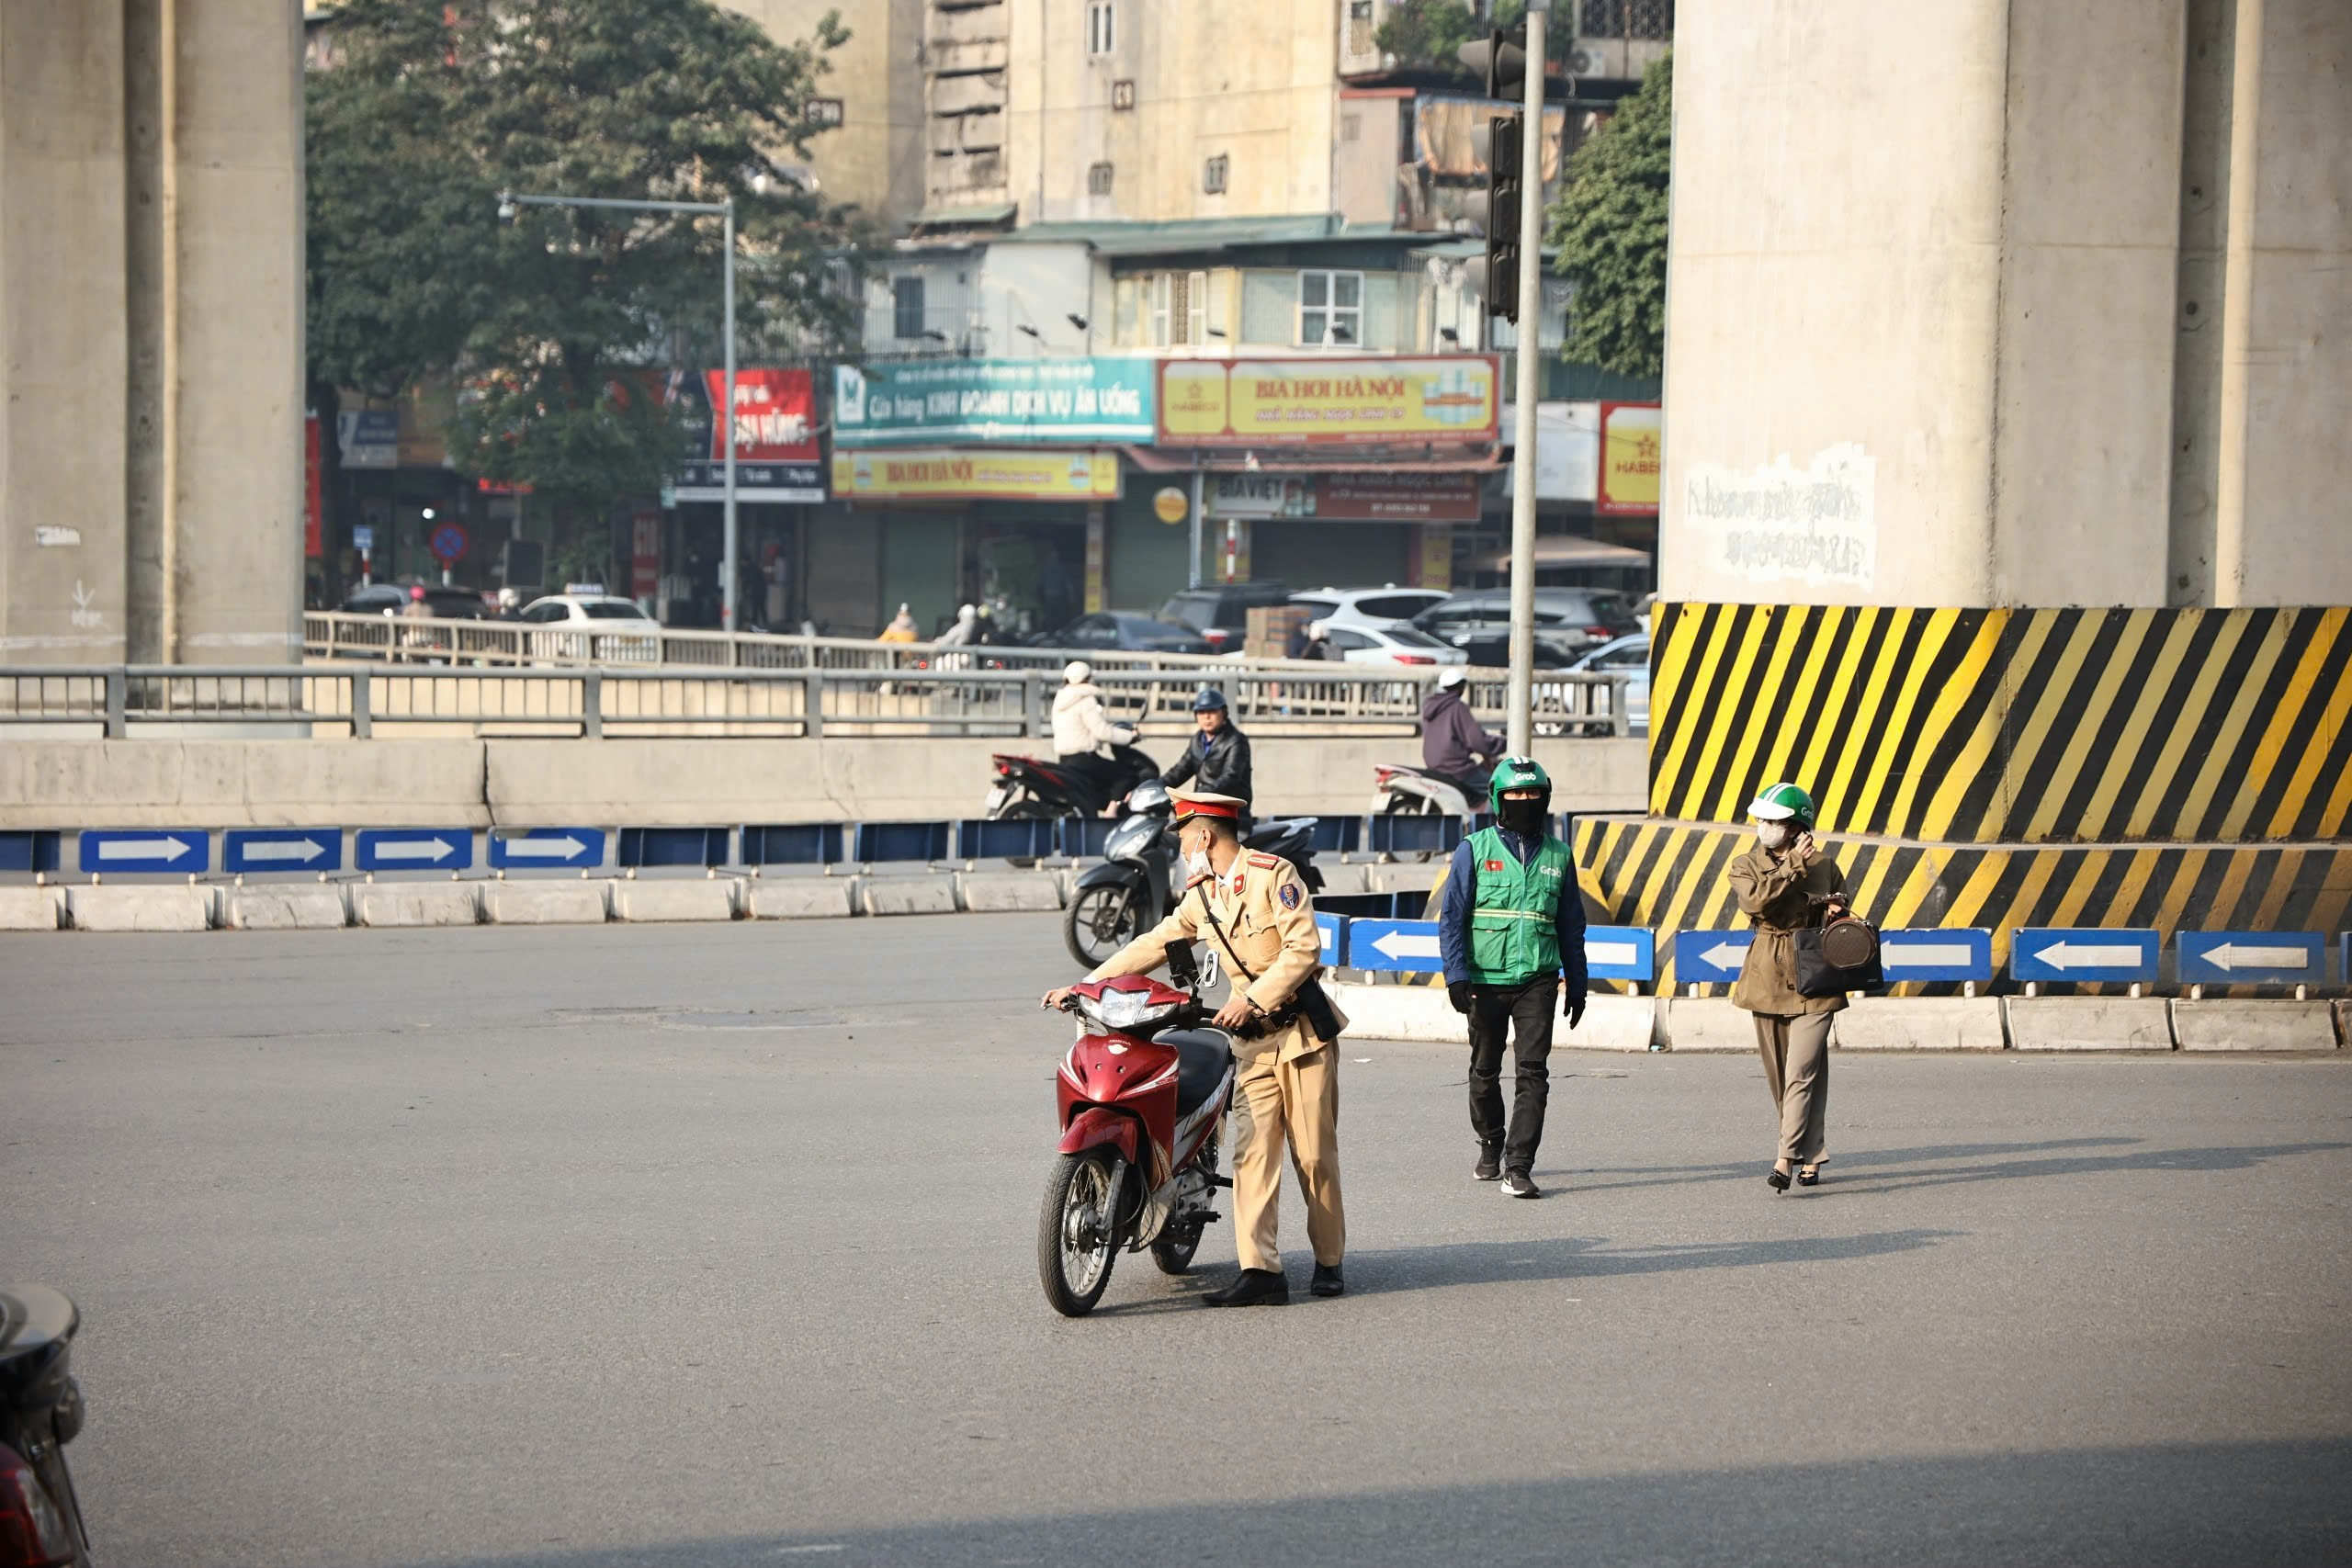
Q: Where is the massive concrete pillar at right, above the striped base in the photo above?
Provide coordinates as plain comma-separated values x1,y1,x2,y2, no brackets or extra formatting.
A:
1660,0,2352,606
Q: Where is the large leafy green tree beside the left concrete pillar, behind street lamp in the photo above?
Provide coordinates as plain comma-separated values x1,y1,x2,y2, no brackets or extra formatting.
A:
306,0,854,503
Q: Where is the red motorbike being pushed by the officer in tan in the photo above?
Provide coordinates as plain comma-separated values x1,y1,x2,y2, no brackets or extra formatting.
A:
1037,950,1235,1316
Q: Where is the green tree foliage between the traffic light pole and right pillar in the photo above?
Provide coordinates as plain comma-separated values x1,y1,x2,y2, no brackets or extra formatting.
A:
1545,54,1675,376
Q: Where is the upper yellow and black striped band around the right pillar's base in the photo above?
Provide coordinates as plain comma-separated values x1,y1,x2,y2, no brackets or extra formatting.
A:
1649,604,2352,846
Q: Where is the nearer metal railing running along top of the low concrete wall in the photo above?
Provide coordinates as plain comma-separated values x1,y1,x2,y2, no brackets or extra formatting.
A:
0,658,1628,739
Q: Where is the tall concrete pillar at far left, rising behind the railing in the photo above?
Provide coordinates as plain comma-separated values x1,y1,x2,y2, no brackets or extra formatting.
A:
0,0,303,663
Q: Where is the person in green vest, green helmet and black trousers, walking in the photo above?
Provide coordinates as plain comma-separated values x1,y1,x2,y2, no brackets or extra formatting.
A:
1437,757,1585,1199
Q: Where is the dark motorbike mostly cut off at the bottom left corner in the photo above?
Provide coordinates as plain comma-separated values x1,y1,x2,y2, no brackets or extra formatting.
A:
0,1286,89,1568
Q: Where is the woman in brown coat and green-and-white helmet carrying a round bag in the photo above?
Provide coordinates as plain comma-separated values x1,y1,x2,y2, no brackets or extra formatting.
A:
1729,783,1847,1192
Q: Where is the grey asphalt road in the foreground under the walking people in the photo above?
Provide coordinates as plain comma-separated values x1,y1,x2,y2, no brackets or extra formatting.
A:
0,917,2352,1568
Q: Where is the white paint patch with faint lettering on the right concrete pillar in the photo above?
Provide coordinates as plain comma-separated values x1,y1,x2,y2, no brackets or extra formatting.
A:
1681,442,1879,590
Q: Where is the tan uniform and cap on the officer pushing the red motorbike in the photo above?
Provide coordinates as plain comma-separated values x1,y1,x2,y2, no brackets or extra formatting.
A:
1087,790,1348,1272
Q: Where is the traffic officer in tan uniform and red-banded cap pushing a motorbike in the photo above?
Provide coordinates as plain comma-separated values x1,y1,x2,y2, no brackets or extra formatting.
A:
1045,790,1348,1307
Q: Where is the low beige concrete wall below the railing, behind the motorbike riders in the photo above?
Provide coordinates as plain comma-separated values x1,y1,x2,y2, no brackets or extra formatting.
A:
0,736,1644,829
